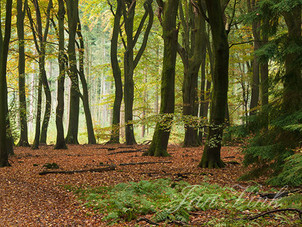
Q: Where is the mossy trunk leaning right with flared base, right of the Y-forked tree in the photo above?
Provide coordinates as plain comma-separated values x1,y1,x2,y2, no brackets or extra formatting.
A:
144,0,179,157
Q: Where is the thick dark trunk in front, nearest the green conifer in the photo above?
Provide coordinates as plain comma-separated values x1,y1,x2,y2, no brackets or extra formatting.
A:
199,0,229,168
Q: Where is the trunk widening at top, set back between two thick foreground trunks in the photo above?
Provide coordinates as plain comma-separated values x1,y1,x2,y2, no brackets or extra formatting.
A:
178,1,206,147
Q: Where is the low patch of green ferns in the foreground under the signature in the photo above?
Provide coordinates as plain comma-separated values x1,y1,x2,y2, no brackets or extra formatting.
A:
66,179,300,226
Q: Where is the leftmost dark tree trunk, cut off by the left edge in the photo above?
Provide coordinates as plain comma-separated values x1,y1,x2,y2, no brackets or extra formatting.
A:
0,0,12,167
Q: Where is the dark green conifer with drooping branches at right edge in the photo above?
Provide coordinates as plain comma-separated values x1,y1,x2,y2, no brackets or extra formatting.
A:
243,0,302,181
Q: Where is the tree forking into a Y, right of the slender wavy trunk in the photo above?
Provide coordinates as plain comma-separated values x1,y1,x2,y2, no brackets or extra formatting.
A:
122,0,153,145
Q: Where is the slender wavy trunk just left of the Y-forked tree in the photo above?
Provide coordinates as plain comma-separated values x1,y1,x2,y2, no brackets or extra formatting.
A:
109,0,123,143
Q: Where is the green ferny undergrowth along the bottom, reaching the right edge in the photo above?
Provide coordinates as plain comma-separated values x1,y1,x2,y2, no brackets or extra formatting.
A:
64,177,302,226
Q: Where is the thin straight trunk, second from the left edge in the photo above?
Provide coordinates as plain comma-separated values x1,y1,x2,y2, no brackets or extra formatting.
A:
17,0,29,147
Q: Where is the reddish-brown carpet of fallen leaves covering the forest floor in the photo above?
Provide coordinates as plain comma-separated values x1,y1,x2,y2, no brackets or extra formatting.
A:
0,145,298,226
